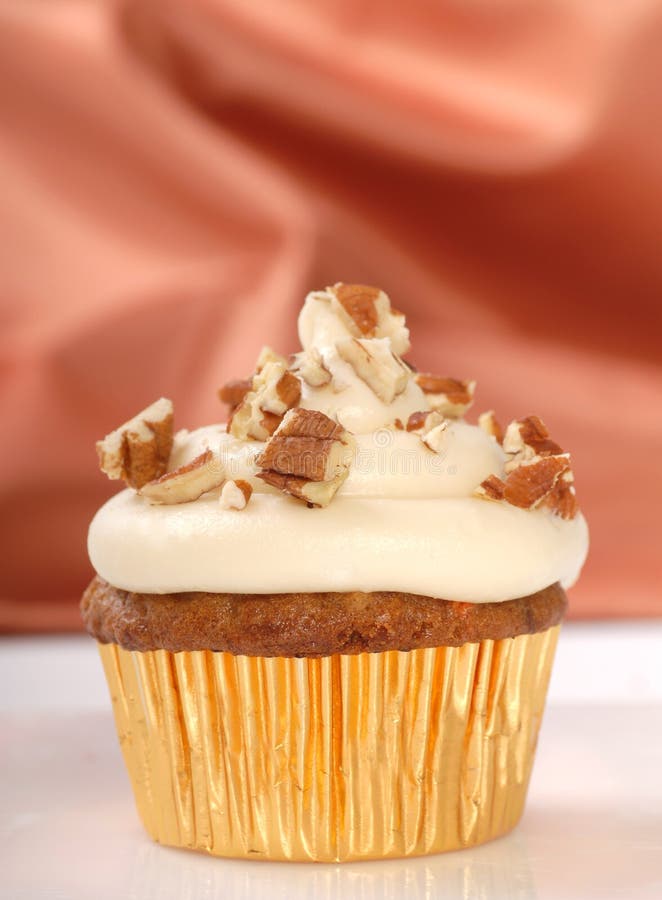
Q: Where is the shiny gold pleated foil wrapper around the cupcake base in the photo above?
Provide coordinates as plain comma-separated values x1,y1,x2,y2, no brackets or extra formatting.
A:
99,626,559,862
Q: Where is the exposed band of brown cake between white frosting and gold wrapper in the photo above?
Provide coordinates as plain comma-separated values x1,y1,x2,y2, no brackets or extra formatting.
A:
81,577,567,657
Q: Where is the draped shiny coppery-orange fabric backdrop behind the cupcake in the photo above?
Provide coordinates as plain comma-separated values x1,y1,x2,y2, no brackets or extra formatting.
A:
0,0,662,630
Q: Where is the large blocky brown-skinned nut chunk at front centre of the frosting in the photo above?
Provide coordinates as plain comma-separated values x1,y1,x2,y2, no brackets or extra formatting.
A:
256,409,356,506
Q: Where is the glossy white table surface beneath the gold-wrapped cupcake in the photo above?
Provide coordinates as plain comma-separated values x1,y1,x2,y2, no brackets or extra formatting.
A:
0,621,662,900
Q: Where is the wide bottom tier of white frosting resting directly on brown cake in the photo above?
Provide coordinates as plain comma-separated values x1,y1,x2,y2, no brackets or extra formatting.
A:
90,490,587,603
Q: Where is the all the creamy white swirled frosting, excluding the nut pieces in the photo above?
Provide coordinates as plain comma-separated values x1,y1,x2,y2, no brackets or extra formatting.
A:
88,284,588,603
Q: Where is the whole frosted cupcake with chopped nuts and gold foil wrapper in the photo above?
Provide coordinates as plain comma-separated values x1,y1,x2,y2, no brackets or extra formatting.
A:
81,284,588,861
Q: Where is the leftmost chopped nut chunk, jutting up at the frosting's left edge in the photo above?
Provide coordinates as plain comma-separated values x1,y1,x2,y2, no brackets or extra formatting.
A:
96,397,173,488
